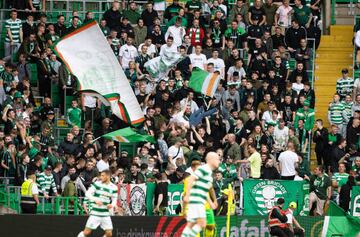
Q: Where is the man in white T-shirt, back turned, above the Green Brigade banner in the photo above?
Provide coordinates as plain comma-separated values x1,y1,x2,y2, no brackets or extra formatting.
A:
279,142,299,180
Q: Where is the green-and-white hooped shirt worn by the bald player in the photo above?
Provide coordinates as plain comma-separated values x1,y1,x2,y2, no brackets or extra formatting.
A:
189,165,213,205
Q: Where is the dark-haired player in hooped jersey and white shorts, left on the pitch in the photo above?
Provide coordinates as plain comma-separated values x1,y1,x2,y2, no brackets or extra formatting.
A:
78,170,118,237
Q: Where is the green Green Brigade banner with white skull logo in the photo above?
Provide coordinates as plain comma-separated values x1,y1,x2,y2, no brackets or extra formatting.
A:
243,179,310,216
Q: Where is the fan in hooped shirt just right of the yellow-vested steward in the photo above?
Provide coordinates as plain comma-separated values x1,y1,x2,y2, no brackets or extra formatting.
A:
36,165,58,199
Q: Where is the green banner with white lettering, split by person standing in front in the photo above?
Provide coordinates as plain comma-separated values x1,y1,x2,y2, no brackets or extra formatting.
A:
146,183,184,216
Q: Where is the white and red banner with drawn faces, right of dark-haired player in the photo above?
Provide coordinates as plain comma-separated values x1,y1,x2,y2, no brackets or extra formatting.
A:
118,184,146,216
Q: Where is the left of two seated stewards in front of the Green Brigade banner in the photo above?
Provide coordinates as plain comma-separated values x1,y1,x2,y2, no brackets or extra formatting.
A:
268,198,294,237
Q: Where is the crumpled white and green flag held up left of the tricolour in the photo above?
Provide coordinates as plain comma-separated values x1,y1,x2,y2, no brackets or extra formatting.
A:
144,52,183,81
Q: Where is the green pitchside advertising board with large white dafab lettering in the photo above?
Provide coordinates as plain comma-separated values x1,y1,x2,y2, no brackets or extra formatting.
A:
215,216,324,237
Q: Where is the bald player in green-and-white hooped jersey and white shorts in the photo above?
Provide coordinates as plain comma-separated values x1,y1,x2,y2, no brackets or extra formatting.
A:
181,152,220,237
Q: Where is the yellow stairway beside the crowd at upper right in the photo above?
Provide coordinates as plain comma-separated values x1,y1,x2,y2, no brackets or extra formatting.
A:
310,25,353,168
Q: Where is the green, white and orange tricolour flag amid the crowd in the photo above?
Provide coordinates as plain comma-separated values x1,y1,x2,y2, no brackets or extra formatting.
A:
189,67,220,97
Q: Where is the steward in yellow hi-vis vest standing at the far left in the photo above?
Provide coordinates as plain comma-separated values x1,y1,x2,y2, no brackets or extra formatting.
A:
20,171,39,214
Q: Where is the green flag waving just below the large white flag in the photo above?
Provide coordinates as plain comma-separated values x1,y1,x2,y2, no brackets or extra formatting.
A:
102,127,155,143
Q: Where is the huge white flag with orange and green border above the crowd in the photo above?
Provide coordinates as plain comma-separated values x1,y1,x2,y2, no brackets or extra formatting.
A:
53,21,144,125
